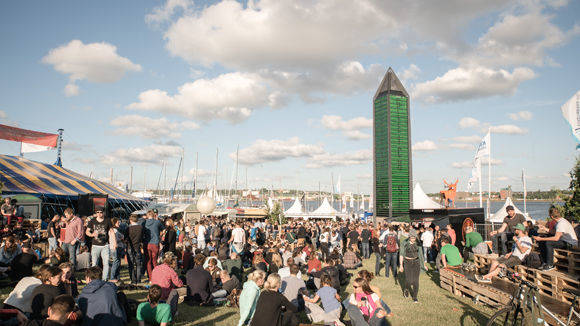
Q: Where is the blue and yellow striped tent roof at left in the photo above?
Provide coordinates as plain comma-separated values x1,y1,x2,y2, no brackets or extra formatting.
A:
0,155,142,201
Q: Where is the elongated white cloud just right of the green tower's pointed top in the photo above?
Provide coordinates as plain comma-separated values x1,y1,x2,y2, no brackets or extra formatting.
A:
413,66,535,103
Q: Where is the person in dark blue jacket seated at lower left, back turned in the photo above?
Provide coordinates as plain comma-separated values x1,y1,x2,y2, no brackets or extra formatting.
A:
77,266,127,326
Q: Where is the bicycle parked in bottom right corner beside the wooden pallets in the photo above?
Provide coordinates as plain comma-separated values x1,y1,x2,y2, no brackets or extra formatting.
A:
487,273,580,326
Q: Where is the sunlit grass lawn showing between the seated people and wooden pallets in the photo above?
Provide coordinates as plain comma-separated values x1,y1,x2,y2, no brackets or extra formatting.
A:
0,257,494,326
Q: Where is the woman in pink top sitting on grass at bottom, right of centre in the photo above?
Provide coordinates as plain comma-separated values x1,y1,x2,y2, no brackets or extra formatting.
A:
348,277,386,326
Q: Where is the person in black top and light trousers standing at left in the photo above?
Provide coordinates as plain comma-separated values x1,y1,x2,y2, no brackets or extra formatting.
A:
85,208,117,280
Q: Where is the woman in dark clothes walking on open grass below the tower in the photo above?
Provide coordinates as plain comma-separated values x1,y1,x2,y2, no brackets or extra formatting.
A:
399,229,428,303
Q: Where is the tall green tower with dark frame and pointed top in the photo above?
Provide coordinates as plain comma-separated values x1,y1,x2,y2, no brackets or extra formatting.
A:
373,67,413,219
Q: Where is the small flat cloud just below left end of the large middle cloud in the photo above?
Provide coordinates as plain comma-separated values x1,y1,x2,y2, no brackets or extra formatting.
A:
111,114,199,139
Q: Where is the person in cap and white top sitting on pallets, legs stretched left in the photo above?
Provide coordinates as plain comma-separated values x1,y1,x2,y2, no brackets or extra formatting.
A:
475,223,532,283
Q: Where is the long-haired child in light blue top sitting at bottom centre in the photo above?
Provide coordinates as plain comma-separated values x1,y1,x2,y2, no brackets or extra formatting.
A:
304,274,344,325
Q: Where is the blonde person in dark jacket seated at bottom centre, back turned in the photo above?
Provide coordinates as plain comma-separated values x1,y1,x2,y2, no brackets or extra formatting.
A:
250,274,298,326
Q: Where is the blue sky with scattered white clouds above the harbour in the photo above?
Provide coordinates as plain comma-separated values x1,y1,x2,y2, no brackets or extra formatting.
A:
0,0,580,192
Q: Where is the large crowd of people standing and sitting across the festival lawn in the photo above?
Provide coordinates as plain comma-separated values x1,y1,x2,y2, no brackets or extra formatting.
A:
0,197,577,326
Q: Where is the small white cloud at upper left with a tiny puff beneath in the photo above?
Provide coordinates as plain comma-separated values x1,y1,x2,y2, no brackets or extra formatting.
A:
42,40,141,96
